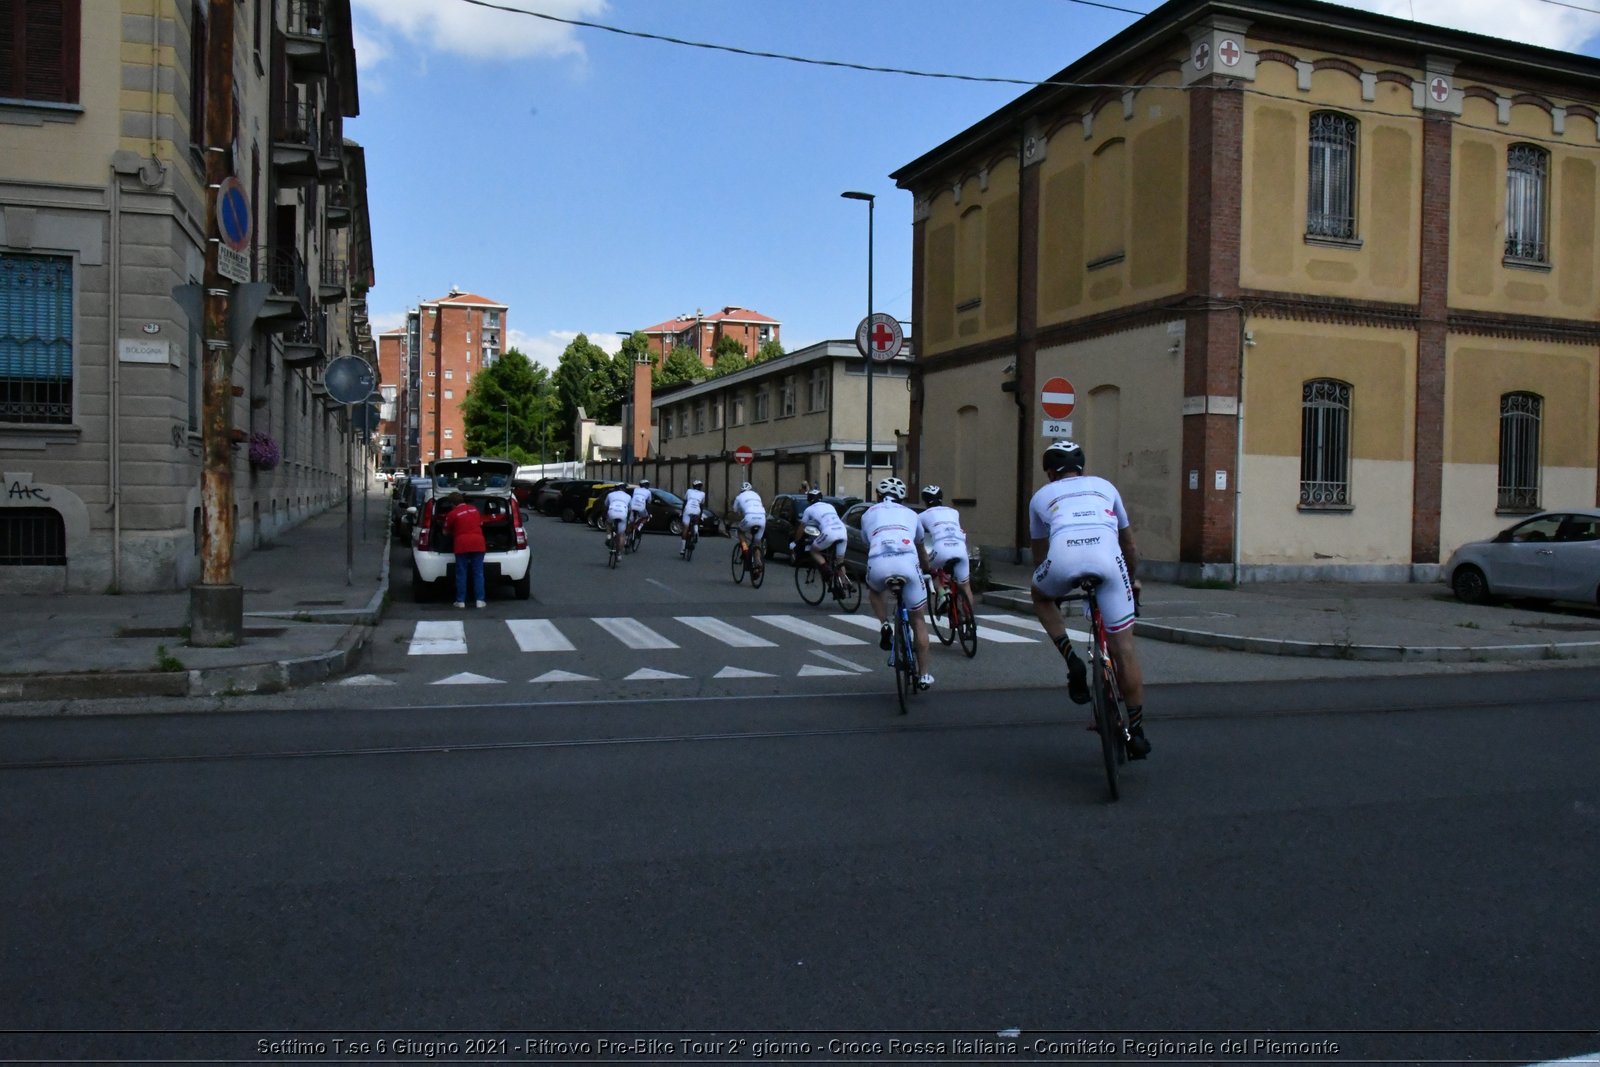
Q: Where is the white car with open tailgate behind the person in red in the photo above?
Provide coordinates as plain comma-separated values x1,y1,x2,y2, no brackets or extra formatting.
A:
411,456,533,601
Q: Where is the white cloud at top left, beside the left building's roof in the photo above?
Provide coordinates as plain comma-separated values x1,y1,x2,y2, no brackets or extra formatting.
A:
355,0,606,67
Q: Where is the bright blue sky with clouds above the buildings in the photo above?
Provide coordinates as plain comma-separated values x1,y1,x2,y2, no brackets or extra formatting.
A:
346,0,1600,366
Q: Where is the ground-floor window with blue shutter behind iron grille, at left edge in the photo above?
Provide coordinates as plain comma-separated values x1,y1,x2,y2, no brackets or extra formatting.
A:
0,253,72,424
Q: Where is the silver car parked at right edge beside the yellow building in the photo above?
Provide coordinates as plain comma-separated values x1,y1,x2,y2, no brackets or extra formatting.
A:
1445,507,1600,605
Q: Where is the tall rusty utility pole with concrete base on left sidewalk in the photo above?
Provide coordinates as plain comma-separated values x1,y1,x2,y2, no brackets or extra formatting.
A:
189,0,245,648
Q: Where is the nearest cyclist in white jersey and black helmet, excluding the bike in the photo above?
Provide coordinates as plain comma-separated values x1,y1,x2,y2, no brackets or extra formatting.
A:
1027,442,1150,760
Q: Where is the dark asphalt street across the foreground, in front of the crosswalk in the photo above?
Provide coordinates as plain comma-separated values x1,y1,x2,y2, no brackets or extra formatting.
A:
0,669,1600,1062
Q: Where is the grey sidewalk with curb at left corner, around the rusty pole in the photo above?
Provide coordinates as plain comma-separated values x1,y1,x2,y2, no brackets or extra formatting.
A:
0,486,389,703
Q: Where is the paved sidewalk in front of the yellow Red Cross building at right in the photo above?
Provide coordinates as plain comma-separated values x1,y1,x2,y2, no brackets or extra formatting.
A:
982,561,1600,662
